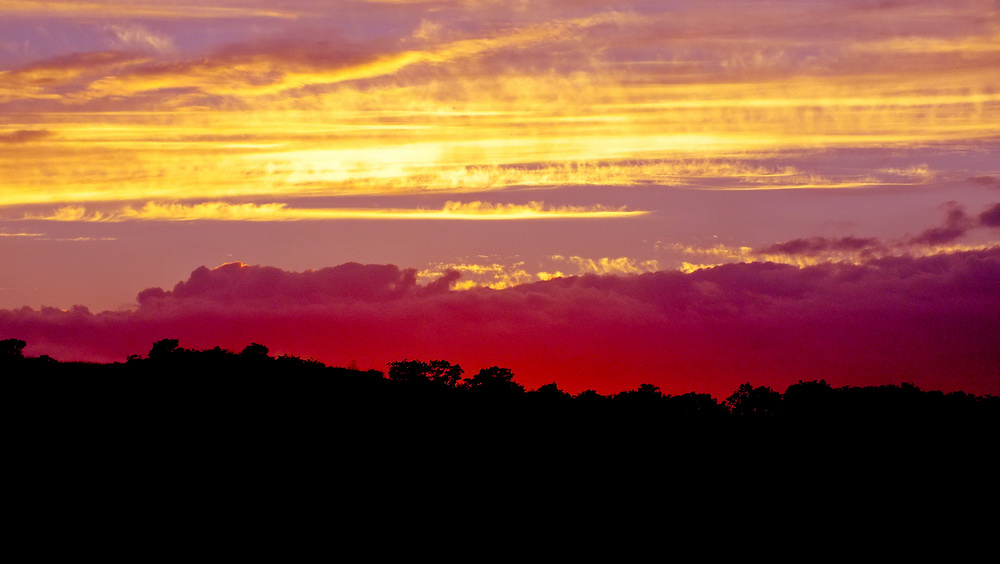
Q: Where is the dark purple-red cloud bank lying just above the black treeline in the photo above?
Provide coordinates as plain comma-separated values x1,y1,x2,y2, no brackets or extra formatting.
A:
0,251,1000,397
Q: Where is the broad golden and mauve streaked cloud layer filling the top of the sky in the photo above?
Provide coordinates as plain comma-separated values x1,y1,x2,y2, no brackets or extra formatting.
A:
0,0,1000,206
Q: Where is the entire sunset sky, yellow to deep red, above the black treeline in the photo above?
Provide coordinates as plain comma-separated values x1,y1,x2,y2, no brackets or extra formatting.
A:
0,0,1000,397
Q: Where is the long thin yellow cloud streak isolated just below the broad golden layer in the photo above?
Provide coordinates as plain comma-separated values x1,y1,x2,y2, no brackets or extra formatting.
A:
25,201,649,223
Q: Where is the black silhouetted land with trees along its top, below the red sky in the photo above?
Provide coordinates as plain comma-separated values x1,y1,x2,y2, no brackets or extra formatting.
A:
0,339,1000,540
